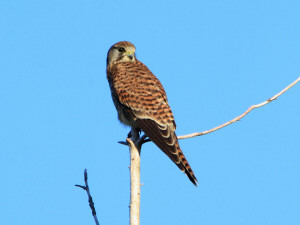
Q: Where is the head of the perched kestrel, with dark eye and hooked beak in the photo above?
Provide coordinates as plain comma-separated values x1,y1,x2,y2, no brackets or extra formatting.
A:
106,41,136,65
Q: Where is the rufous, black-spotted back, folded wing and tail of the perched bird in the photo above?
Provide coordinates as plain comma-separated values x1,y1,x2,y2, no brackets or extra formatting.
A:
108,61,197,185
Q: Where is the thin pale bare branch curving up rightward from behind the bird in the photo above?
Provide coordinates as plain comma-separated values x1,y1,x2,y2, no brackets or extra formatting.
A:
178,77,300,139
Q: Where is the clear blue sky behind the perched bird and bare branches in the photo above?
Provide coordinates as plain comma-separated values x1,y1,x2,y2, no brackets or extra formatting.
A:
0,0,300,225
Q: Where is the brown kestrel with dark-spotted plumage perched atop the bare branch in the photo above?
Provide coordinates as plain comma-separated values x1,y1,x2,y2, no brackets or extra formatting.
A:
106,41,197,186
